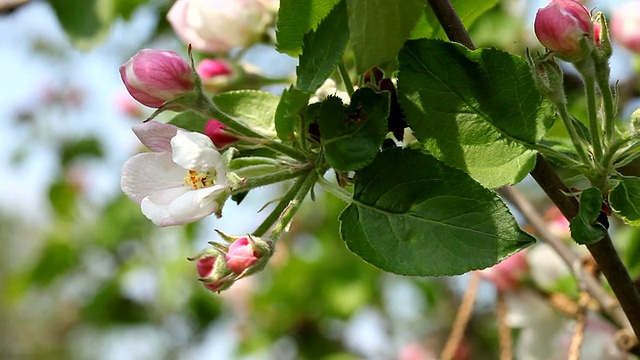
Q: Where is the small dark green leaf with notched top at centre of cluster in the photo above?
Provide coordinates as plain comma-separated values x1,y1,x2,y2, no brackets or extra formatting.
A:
318,88,390,170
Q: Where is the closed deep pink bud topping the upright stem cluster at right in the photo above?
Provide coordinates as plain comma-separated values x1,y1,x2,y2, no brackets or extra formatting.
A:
534,0,593,56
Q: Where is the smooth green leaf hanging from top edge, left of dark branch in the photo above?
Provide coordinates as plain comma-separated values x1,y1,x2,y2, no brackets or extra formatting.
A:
346,0,425,73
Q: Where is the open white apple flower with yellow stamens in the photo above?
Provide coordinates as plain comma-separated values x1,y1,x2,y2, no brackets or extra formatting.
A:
121,121,230,226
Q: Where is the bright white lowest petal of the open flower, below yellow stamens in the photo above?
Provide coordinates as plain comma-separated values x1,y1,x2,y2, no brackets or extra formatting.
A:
169,186,226,224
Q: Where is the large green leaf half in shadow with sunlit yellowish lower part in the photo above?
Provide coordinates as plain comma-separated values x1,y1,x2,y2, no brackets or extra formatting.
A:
398,39,554,187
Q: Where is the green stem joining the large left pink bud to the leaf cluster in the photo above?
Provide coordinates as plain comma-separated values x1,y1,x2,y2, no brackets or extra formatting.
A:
192,94,307,161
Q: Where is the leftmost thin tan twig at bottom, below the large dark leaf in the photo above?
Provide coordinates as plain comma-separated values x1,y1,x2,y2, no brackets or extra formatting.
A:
439,271,480,360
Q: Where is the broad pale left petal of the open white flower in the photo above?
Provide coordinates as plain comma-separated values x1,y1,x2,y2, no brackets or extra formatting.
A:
120,152,189,204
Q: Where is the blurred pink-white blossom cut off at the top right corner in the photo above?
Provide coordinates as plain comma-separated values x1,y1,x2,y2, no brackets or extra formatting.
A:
611,1,640,53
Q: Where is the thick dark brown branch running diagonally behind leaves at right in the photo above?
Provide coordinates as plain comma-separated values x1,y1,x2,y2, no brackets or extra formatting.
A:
428,0,640,337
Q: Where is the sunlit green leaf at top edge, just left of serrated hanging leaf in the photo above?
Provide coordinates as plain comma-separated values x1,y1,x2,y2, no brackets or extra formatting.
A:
276,0,340,56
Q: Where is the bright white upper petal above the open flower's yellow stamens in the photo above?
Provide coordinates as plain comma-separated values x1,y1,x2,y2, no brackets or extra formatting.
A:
171,129,222,172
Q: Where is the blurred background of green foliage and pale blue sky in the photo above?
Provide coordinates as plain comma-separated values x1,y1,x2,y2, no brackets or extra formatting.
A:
0,0,640,360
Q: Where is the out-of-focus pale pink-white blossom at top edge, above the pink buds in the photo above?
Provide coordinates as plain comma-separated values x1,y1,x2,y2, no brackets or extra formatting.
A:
167,0,274,54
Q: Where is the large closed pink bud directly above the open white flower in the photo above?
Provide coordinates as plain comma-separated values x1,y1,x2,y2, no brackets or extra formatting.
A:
120,49,195,108
